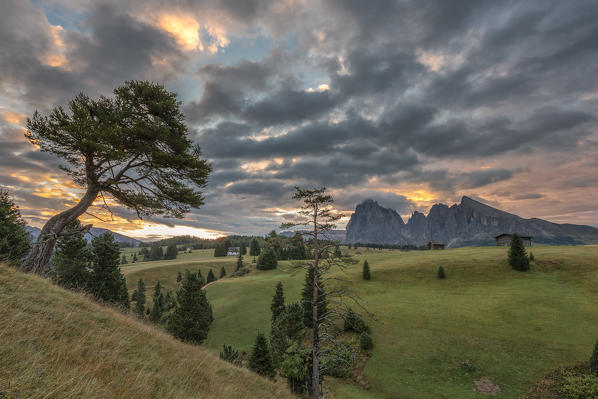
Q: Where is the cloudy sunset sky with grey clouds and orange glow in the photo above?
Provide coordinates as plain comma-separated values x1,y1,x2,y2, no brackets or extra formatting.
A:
0,0,598,239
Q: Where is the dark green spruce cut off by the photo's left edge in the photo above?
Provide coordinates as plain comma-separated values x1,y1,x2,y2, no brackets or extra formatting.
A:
0,189,31,266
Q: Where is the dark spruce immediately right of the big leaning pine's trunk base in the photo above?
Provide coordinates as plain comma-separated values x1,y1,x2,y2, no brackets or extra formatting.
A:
50,220,91,290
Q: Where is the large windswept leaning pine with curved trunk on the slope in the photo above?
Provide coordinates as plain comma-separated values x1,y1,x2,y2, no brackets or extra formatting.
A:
21,81,211,274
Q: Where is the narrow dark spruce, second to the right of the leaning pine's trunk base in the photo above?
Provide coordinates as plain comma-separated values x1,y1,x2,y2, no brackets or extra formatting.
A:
89,233,129,308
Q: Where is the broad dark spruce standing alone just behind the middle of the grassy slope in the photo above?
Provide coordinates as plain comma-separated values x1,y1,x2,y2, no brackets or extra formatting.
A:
167,270,212,344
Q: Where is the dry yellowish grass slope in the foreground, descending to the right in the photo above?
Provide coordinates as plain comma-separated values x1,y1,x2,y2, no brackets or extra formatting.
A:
0,266,291,399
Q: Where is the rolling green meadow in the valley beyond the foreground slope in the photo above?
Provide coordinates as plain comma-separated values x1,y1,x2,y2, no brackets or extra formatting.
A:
122,246,598,399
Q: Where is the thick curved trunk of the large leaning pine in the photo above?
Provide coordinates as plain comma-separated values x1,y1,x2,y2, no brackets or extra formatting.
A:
21,187,100,274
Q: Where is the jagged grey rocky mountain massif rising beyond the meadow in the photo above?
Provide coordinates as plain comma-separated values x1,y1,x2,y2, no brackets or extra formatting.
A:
344,197,598,247
